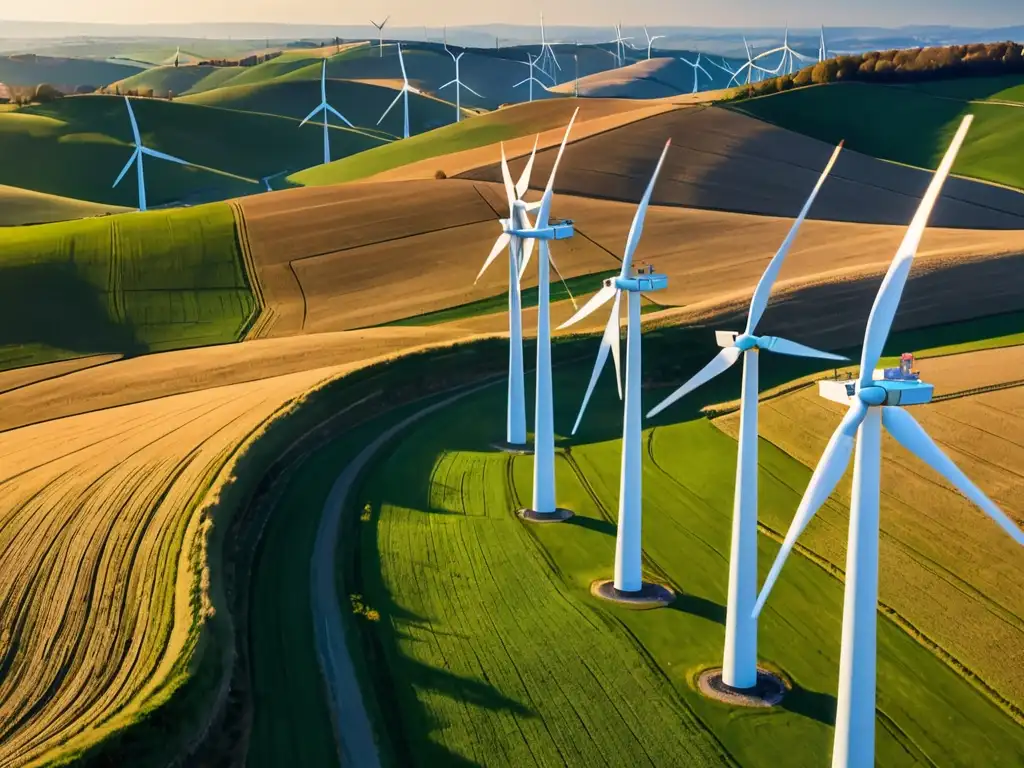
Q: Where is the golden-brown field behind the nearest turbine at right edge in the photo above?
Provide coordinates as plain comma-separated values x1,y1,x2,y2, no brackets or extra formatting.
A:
716,366,1024,720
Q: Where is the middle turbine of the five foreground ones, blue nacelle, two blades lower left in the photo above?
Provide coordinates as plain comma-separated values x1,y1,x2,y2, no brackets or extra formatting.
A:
560,139,672,593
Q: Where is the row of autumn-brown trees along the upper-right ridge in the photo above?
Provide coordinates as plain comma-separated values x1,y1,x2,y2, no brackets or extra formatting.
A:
736,42,1024,98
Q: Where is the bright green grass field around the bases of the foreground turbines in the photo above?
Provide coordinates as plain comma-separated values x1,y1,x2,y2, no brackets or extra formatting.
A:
342,360,1024,766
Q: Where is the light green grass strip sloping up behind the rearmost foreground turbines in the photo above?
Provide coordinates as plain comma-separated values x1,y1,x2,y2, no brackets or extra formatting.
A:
288,99,581,186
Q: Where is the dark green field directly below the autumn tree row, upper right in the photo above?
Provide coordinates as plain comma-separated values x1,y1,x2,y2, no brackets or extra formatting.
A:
731,79,1024,188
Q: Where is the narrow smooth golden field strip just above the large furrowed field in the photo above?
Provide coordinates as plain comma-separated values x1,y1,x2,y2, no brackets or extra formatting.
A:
0,326,474,433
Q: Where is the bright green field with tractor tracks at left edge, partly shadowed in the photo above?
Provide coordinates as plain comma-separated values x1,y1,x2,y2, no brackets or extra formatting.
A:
0,204,255,370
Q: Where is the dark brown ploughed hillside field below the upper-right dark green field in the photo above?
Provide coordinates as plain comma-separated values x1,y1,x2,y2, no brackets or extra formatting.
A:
461,106,1024,229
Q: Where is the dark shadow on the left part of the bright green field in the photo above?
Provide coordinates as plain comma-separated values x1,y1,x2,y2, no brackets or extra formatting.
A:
0,263,144,362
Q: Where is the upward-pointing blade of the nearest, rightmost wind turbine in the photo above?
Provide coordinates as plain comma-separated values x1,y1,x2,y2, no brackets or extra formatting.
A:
860,115,974,387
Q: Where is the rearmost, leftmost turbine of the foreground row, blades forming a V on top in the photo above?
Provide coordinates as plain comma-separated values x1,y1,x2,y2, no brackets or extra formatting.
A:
473,140,540,445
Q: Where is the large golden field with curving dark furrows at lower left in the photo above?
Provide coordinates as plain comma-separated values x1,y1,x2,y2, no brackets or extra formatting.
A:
0,370,339,765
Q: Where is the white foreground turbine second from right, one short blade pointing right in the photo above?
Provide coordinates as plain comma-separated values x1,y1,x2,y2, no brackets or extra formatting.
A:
647,144,846,688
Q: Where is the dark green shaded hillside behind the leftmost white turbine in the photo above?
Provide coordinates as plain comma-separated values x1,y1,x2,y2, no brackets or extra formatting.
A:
0,96,380,207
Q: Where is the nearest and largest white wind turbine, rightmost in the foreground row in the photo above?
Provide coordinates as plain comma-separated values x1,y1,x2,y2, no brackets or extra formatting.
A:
754,116,1024,768
